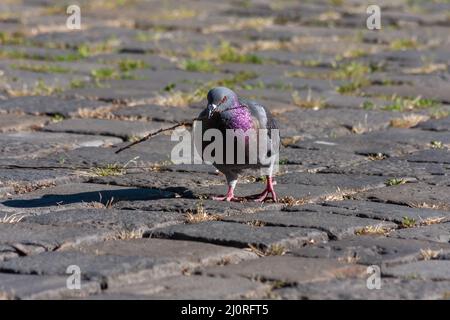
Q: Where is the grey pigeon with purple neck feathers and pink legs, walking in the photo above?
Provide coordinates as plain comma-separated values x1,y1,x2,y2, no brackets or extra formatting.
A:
194,87,279,202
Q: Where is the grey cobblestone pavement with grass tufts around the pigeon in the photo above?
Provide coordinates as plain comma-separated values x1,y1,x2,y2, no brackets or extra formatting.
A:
0,0,450,299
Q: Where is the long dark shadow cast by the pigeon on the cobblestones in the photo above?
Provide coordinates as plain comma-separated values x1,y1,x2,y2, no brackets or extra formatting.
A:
2,187,190,208
